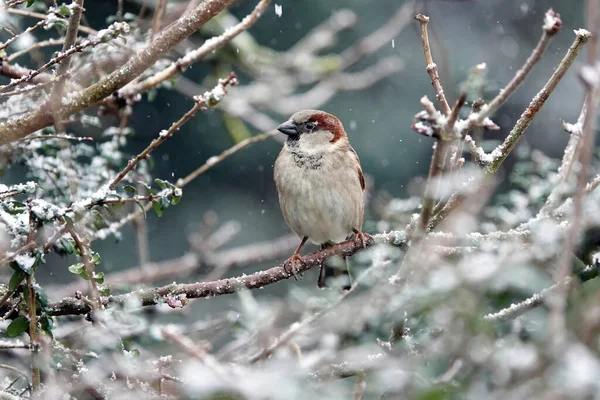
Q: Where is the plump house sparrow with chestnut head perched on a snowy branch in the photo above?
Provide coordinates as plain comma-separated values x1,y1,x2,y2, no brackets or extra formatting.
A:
275,110,368,288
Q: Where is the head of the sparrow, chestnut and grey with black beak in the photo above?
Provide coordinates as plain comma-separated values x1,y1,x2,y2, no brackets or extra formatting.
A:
277,110,348,153
